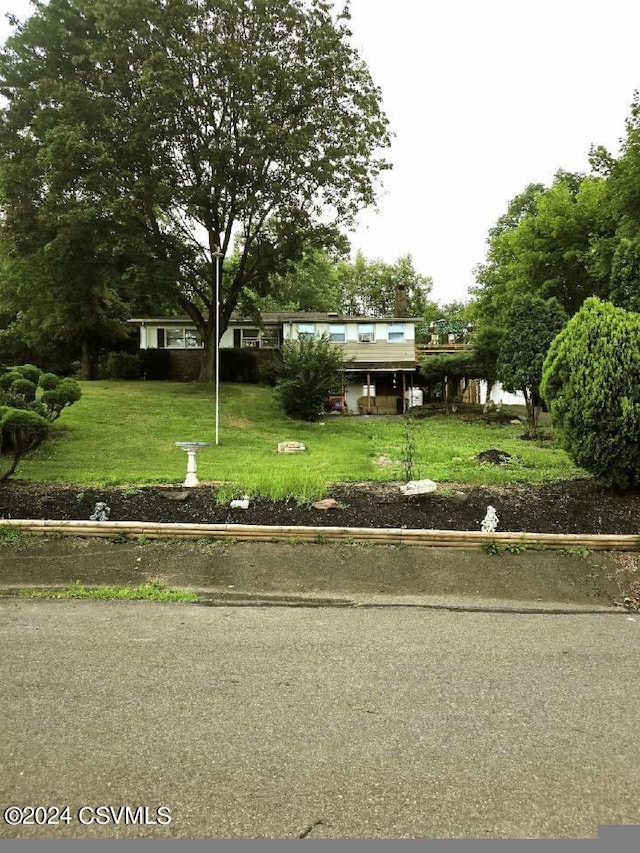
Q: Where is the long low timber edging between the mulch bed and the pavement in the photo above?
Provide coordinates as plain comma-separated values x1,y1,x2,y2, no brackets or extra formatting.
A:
0,519,640,551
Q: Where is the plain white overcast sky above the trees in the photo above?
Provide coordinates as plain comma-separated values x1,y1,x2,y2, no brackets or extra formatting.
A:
0,0,640,302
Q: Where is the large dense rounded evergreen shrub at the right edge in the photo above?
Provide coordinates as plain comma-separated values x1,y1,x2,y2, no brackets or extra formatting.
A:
540,297,640,489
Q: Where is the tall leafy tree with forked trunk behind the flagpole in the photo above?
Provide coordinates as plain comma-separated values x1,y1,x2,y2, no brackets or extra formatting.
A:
0,0,389,379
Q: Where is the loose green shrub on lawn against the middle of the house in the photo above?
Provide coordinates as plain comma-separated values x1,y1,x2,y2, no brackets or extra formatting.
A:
274,335,345,421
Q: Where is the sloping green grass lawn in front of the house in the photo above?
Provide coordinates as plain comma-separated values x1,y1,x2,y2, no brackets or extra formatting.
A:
18,382,585,500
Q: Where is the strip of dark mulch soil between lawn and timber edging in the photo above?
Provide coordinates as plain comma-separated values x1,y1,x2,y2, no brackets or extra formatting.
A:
0,480,640,534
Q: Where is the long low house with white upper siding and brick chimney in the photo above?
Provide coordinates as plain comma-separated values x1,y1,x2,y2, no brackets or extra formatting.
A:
129,302,421,414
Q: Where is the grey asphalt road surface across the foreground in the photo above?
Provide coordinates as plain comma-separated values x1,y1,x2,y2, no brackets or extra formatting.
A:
0,600,640,838
